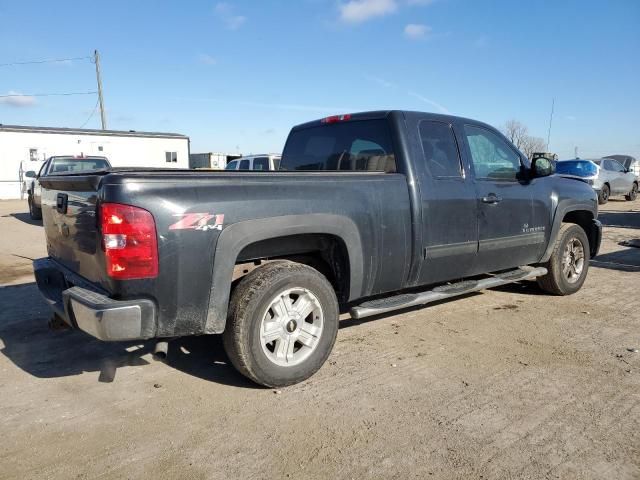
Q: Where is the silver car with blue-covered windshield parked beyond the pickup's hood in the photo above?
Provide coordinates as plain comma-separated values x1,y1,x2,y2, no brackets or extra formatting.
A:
556,158,638,205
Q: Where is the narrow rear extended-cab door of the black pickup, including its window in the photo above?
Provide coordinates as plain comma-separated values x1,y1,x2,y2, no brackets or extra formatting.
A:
408,118,478,285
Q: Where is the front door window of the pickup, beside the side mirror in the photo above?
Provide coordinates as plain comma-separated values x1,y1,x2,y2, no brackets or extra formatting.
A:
464,125,520,181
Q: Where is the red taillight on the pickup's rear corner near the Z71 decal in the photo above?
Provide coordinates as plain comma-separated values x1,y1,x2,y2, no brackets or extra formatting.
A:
100,203,158,280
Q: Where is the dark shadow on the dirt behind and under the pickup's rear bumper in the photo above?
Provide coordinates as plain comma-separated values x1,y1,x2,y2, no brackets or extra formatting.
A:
0,283,259,388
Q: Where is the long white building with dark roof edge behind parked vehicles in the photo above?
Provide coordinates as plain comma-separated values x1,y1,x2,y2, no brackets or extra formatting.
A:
0,124,189,199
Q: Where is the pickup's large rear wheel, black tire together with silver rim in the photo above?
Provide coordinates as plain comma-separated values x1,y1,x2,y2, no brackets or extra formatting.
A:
223,260,339,387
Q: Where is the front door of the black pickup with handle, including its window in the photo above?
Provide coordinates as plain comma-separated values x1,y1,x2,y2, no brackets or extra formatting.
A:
463,124,550,273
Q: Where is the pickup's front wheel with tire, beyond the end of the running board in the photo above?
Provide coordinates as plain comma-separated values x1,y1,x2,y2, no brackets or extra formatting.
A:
537,223,590,295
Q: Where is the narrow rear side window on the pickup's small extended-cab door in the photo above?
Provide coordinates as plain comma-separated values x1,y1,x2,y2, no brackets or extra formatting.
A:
419,120,462,178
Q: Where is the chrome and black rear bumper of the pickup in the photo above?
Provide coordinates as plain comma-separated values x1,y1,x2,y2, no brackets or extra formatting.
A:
33,258,156,341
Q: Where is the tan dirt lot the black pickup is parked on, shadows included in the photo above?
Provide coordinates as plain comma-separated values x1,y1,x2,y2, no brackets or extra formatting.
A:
0,197,640,479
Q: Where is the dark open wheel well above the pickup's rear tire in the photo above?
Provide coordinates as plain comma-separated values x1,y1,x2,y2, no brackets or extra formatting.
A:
234,234,350,303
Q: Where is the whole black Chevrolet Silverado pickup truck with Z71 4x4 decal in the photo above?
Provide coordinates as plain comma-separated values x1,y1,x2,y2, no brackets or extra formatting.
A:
34,111,601,386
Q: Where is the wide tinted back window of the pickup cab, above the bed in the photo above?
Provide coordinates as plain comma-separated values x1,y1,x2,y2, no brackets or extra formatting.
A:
280,120,396,172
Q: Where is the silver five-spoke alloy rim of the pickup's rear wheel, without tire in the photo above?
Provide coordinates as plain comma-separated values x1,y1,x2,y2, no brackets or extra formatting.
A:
260,287,324,367
